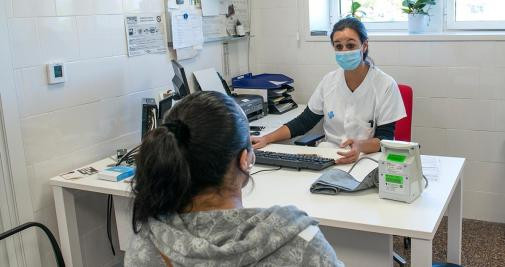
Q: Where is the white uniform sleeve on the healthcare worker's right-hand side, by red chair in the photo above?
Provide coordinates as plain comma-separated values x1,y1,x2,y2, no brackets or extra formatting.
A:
377,80,407,126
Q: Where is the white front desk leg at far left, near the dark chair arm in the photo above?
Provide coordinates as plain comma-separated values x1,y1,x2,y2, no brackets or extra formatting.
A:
53,186,83,267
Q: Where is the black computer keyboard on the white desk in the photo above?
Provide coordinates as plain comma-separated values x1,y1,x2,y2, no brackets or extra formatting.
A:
254,150,335,171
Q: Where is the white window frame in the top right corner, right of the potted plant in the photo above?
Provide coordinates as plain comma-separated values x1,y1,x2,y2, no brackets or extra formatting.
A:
444,0,505,31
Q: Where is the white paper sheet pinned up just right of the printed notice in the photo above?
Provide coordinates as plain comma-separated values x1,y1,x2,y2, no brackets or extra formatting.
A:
171,10,203,49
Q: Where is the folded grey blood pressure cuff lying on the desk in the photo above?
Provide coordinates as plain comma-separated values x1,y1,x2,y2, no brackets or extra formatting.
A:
310,168,379,195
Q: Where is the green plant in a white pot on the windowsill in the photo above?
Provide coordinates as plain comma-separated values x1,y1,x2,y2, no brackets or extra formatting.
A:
402,0,436,33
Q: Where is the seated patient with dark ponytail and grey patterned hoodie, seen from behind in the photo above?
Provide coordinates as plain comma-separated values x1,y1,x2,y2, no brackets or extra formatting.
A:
124,92,344,267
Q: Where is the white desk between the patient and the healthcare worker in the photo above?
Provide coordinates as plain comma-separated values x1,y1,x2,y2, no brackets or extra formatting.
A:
50,107,464,266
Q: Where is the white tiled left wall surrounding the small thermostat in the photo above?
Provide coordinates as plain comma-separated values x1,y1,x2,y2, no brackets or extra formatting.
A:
1,0,248,266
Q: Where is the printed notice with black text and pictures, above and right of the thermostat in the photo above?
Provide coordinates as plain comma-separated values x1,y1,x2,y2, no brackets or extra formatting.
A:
125,15,167,57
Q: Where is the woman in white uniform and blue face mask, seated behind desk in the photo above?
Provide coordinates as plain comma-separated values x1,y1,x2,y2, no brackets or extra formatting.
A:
251,18,406,164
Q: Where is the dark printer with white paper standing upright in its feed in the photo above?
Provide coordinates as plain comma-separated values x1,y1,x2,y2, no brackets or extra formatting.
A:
193,68,266,121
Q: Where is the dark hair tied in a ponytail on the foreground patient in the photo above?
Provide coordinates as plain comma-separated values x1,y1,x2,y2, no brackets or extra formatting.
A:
132,92,251,232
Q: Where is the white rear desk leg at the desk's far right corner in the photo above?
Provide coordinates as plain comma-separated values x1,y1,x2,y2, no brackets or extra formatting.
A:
447,178,463,264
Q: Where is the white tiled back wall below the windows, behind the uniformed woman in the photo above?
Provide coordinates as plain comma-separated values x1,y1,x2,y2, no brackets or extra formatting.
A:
251,0,505,222
